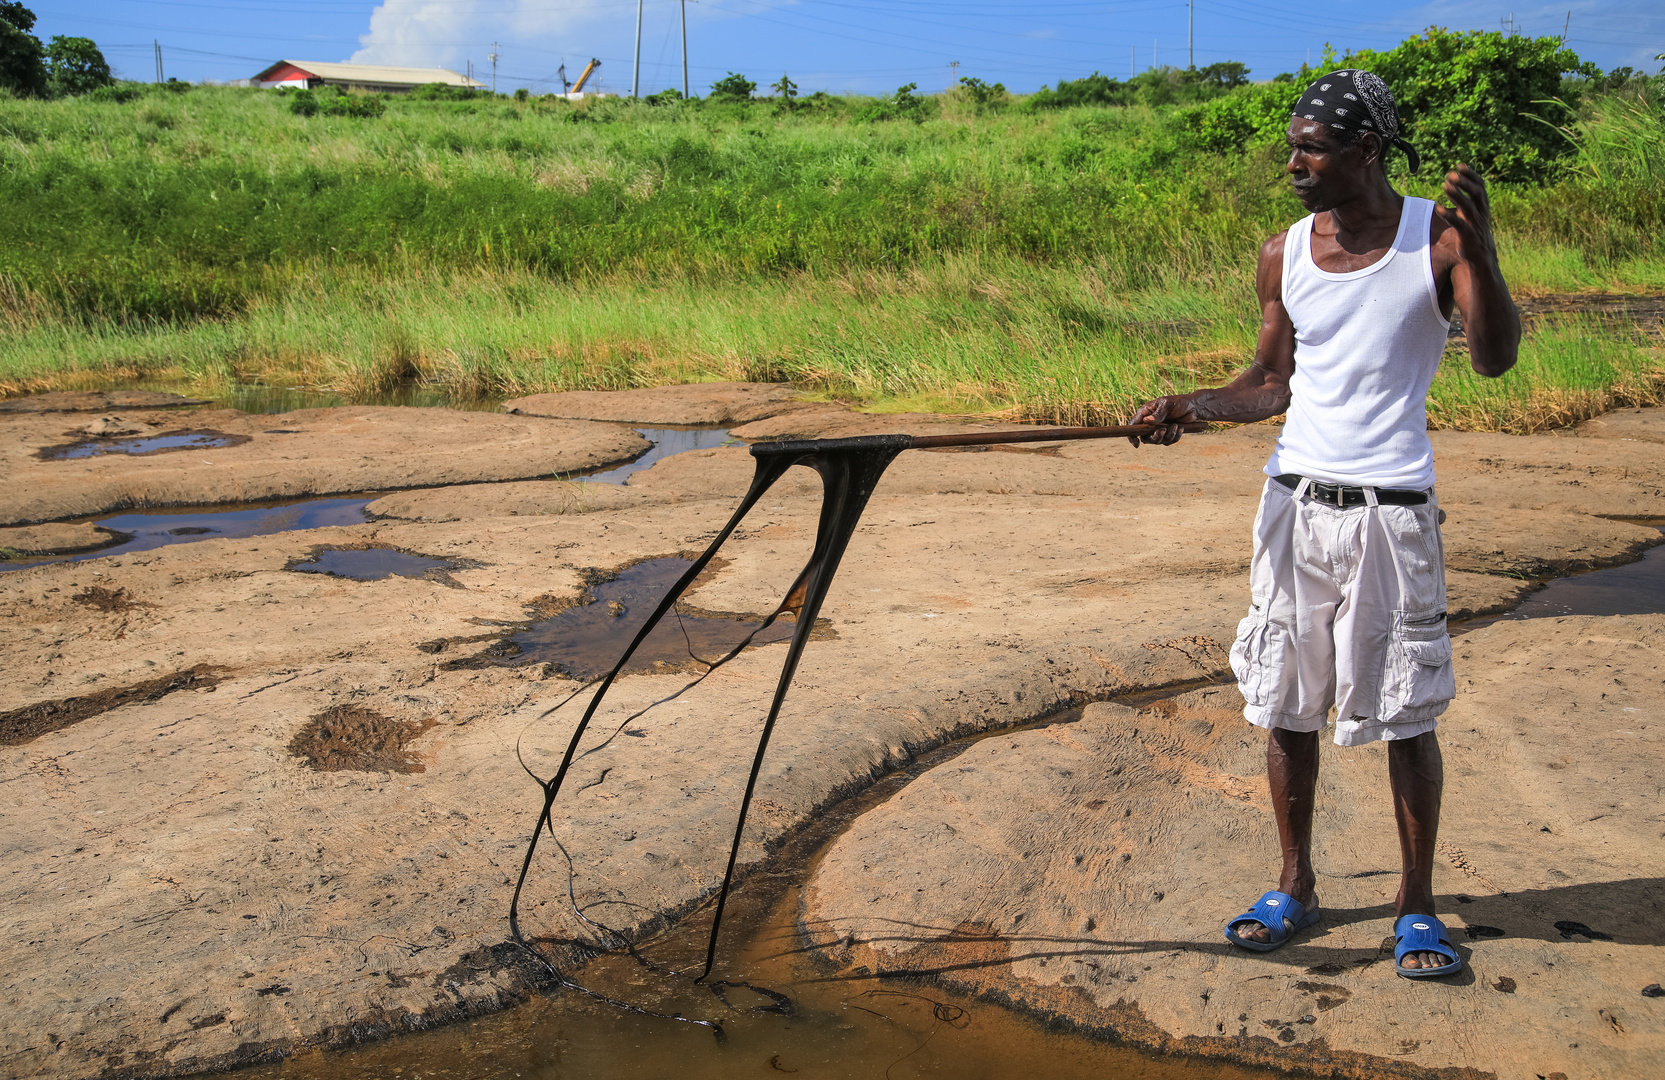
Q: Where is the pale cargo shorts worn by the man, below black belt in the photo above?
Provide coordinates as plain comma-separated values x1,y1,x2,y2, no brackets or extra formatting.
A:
1232,479,1457,746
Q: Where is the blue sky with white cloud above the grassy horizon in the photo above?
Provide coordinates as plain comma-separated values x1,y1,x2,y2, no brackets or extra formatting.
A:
25,0,1665,93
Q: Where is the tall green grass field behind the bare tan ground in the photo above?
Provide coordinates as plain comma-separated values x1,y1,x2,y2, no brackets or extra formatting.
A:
0,81,1665,429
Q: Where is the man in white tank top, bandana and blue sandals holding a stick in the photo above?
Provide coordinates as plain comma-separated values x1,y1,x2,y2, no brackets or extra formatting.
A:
1131,70,1520,978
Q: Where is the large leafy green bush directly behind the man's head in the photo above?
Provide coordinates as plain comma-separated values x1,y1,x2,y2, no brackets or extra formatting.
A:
1342,27,1600,181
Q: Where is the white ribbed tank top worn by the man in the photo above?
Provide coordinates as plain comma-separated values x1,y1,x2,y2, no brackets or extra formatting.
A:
1265,198,1450,489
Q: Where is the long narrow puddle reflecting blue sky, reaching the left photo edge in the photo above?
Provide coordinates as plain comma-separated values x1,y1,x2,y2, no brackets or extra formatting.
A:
0,496,371,572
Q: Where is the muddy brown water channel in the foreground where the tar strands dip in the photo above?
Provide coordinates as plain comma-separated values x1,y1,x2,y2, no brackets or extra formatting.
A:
246,698,1282,1080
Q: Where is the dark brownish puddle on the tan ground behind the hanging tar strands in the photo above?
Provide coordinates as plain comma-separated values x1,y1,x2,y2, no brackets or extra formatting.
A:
488,557,794,681
